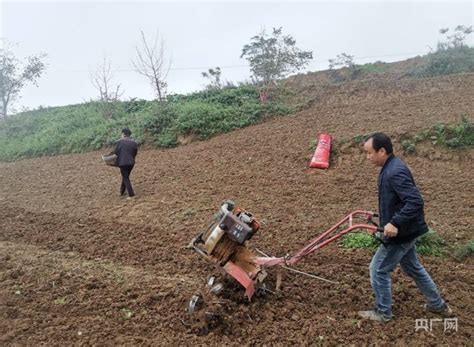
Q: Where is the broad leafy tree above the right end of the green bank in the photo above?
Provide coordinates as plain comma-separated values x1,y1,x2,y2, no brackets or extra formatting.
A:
240,27,313,86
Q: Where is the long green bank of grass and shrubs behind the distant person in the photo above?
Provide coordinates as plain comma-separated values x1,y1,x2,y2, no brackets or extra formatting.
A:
0,85,294,161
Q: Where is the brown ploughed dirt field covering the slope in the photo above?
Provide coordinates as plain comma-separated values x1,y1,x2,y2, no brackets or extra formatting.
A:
0,74,474,345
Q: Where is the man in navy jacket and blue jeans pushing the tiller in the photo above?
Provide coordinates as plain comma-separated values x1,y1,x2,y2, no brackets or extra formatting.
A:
359,133,452,322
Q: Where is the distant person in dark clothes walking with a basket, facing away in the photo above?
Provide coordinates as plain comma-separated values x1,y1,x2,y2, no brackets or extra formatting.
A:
112,128,138,199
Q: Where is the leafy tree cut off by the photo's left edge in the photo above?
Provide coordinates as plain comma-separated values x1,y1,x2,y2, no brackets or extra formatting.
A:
0,45,46,118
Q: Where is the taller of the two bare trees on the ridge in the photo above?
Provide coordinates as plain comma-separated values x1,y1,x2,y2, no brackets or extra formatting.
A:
132,31,171,101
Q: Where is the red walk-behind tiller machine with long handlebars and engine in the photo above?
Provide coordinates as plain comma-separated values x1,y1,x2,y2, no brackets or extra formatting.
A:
188,200,382,307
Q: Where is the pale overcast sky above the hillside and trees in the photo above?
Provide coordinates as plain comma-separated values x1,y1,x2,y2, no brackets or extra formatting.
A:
0,0,474,113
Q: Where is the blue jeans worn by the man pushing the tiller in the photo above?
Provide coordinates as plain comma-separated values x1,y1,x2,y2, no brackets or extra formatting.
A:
369,239,445,318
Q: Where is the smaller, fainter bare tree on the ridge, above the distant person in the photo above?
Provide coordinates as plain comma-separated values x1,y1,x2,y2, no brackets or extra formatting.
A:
90,57,124,102
